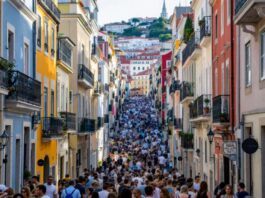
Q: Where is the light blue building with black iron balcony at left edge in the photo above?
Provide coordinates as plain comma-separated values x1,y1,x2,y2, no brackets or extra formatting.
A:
0,0,41,191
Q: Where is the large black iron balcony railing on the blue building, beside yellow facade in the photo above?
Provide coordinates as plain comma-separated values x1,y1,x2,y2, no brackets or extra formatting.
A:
7,71,41,106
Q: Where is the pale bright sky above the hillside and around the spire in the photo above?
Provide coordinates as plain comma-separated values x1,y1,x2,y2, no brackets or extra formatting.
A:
98,0,191,26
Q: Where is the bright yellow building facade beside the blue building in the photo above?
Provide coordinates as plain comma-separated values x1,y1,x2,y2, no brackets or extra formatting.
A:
36,1,59,182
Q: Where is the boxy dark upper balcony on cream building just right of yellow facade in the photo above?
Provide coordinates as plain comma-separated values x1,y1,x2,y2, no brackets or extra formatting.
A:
57,38,72,67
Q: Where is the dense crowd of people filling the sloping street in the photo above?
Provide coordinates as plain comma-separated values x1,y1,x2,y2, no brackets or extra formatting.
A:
0,96,248,198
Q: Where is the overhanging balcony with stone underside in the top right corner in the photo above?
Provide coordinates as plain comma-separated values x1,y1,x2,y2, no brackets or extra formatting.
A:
234,0,265,25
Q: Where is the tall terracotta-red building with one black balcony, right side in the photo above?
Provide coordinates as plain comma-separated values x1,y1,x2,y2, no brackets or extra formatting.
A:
212,0,236,184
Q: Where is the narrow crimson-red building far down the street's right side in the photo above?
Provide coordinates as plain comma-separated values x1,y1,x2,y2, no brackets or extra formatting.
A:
161,51,172,123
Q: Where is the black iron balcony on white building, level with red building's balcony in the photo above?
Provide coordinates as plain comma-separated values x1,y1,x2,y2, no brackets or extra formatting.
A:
190,95,211,121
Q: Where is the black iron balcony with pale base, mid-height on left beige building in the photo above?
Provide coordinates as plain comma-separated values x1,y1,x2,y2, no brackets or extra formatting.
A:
78,64,94,89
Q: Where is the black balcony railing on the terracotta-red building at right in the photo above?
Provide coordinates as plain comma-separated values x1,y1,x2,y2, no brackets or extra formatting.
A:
212,95,230,123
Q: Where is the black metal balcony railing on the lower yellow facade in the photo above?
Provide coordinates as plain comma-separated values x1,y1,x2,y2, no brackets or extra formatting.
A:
42,117,63,138
